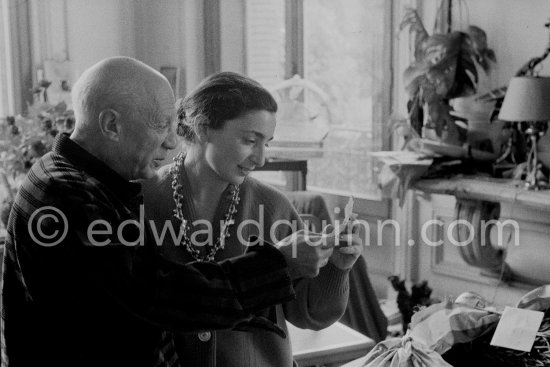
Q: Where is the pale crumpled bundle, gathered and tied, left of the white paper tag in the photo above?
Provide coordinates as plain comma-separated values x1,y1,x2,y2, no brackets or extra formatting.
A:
364,292,500,367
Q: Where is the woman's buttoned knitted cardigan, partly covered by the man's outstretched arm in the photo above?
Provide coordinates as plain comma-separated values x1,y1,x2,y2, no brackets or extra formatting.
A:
143,165,349,367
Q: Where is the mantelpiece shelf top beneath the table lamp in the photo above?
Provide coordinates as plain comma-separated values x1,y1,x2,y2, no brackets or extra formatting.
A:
413,176,550,210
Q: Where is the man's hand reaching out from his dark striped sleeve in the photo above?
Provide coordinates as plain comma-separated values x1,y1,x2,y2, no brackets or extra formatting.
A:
275,229,335,278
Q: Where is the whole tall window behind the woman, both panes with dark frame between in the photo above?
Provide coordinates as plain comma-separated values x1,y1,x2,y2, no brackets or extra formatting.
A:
245,0,391,198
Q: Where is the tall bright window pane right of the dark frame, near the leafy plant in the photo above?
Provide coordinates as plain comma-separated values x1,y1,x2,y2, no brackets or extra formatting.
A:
304,0,390,196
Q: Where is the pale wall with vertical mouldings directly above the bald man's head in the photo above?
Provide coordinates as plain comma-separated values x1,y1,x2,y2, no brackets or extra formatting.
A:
31,0,204,95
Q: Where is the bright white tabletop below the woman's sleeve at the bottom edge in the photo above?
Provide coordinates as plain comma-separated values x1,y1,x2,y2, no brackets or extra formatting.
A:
287,322,376,367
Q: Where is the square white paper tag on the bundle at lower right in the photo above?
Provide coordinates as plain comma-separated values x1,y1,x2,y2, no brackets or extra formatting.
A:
491,307,544,352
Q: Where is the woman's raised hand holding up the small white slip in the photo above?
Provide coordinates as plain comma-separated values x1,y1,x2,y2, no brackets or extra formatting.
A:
323,224,363,270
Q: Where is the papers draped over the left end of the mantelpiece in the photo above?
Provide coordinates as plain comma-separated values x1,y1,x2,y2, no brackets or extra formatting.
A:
370,150,433,206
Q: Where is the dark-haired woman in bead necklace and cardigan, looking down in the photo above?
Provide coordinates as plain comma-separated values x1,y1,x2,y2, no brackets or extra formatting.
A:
144,72,362,367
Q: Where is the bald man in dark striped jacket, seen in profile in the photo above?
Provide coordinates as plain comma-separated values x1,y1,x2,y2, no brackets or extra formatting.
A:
2,57,294,367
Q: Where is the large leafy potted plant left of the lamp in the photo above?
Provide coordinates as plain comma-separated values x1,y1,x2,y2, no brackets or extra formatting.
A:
400,8,496,144
